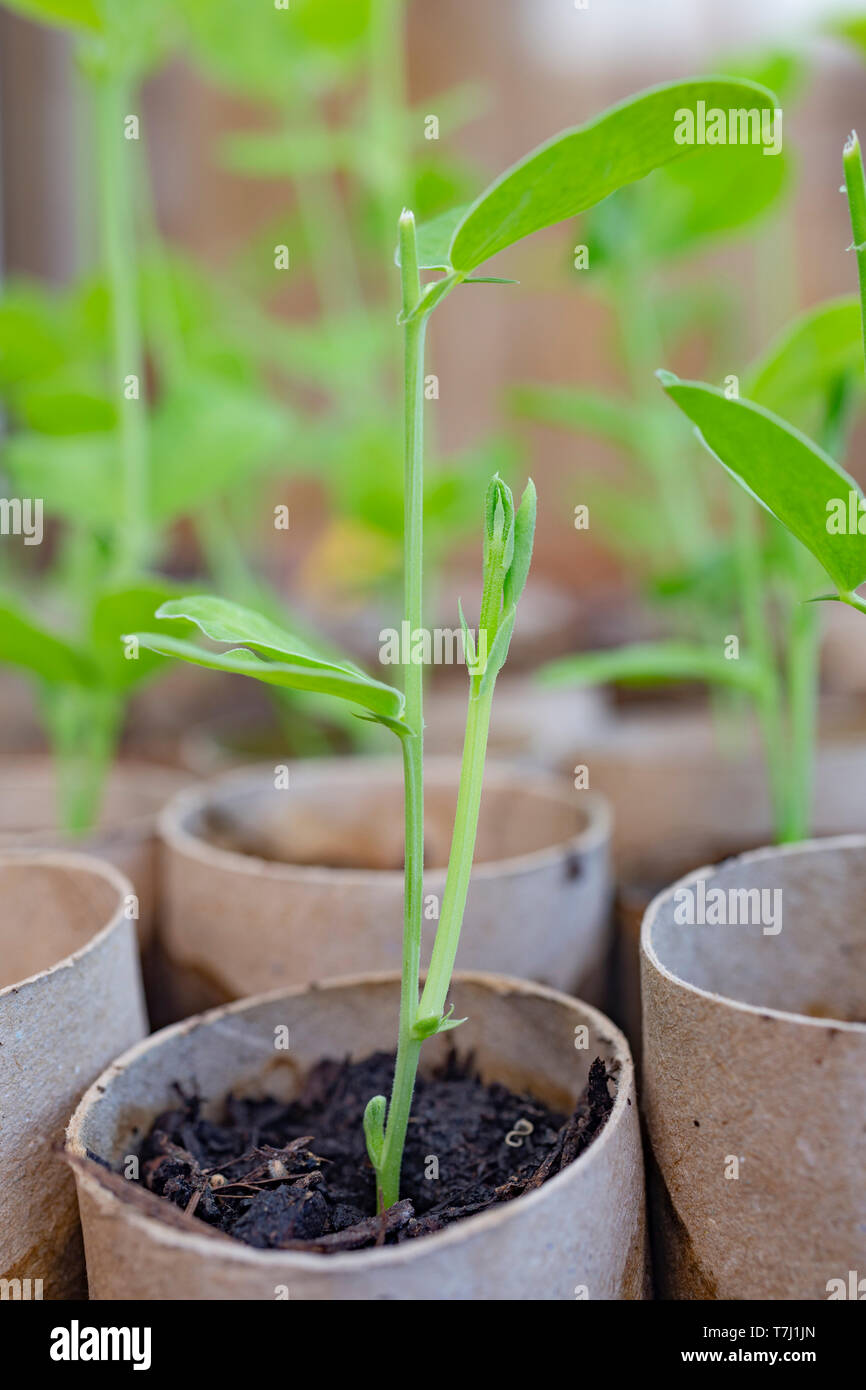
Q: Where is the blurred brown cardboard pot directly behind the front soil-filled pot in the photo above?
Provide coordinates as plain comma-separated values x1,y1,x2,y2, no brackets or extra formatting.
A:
158,758,610,1017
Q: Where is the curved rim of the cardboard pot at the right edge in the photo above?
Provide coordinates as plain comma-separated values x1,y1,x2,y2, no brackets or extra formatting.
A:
641,834,866,1037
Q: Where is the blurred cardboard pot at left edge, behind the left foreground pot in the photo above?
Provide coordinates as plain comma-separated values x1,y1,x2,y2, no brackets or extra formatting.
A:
0,756,190,947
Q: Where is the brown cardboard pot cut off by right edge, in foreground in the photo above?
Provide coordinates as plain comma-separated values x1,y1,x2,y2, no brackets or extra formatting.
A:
641,835,866,1300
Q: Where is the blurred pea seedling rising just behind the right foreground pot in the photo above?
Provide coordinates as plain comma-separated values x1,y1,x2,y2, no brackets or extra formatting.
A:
539,283,862,841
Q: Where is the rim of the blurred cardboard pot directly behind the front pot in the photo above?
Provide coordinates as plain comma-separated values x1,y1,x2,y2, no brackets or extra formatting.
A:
157,758,613,887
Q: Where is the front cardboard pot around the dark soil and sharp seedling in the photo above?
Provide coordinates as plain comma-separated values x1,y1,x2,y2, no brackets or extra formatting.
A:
67,974,645,1301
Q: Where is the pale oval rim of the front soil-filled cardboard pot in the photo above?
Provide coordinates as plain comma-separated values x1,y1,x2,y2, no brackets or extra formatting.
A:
65,970,635,1275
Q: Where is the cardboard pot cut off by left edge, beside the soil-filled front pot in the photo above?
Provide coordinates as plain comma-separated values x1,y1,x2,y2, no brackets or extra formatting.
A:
0,851,147,1298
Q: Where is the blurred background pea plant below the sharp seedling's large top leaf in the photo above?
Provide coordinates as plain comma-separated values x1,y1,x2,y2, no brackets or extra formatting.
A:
509,51,801,678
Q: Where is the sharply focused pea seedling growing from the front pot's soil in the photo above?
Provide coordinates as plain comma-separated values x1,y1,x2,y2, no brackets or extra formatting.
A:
135,79,773,1208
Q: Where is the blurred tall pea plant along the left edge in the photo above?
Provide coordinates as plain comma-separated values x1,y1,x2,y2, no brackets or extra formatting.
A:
0,0,193,831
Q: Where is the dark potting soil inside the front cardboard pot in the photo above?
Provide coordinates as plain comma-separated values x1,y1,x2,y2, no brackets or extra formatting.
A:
140,1052,613,1252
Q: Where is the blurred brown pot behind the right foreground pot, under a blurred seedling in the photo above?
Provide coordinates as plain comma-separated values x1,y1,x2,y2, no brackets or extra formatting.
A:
563,701,866,1061
